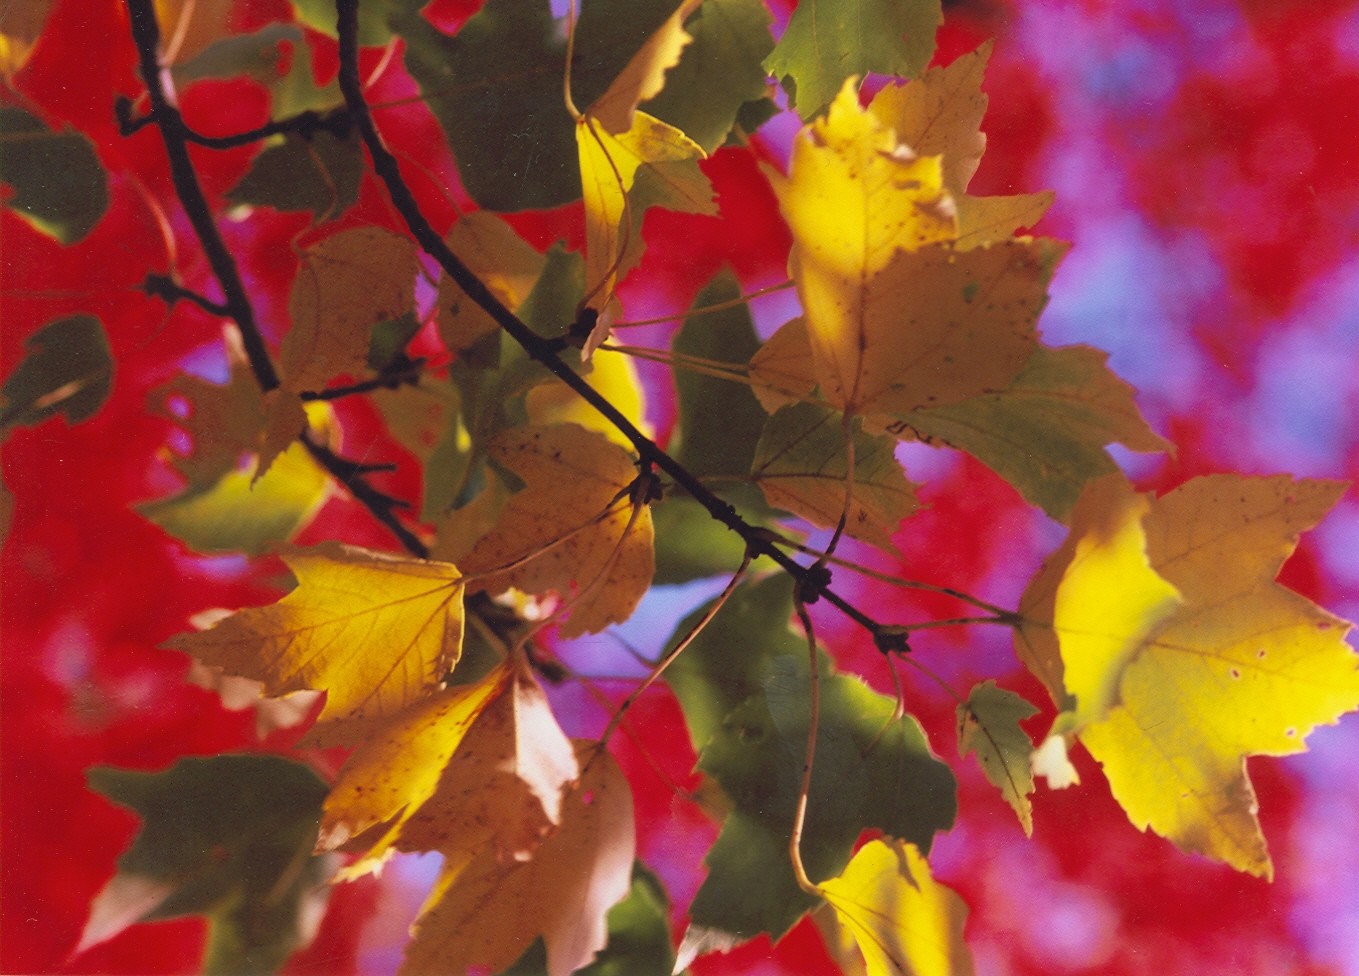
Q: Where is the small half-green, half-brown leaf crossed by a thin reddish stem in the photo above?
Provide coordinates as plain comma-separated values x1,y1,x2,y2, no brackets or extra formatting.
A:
750,404,919,552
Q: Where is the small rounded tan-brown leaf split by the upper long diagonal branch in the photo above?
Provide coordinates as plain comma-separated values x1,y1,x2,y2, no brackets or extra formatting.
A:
436,211,546,352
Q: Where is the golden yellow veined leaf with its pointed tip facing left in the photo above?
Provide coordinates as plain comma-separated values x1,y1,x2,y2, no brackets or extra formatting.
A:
166,542,463,746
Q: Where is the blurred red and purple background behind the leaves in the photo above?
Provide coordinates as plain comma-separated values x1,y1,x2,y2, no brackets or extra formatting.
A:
0,0,1359,976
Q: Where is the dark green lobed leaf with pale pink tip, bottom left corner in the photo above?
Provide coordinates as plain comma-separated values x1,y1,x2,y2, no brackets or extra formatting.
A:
76,754,329,973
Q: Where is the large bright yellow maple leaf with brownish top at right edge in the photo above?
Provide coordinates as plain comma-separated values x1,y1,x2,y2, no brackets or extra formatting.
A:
1019,474,1359,877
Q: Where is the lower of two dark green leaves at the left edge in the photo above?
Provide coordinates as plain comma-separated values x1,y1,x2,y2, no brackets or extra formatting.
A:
0,315,113,435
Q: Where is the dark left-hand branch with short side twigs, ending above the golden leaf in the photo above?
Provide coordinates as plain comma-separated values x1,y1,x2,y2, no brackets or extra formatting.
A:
127,0,429,559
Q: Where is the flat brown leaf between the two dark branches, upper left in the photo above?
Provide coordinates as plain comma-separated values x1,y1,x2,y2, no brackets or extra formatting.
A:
279,227,419,393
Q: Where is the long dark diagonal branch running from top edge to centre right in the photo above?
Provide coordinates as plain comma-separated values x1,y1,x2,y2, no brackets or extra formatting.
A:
328,0,883,636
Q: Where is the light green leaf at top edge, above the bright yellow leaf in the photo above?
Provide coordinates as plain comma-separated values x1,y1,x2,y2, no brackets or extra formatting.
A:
764,0,943,118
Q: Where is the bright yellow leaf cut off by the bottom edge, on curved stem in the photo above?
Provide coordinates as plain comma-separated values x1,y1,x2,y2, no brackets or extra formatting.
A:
817,840,973,976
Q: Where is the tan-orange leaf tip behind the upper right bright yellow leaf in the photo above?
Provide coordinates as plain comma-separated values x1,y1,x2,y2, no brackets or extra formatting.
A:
868,41,993,197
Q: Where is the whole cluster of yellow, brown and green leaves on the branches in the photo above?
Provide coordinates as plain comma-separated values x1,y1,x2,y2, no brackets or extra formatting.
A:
0,0,1359,976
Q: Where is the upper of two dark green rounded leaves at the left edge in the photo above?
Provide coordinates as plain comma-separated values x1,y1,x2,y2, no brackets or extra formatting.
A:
0,105,109,245
